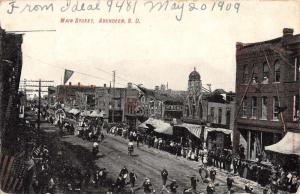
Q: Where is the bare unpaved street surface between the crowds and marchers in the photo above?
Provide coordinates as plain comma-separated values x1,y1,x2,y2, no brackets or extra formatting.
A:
61,134,262,194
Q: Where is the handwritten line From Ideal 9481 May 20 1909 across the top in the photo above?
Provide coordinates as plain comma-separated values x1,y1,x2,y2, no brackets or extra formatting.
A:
6,0,240,21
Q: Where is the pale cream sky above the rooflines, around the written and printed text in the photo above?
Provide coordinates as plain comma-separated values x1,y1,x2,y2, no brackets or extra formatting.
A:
0,0,300,91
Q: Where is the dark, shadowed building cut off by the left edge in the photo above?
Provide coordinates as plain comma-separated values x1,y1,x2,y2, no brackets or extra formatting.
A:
0,27,23,152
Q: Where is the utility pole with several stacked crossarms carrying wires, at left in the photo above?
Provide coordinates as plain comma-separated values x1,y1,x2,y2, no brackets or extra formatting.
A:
24,79,54,130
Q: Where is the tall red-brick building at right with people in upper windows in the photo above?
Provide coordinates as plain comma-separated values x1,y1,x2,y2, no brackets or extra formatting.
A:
233,29,300,159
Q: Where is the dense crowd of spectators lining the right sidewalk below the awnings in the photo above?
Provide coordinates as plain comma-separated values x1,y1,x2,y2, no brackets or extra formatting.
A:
104,122,300,194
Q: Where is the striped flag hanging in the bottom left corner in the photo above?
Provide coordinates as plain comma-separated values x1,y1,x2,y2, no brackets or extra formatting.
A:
0,153,25,193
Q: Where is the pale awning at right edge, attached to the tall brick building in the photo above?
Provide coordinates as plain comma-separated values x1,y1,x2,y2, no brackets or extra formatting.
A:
265,132,300,156
